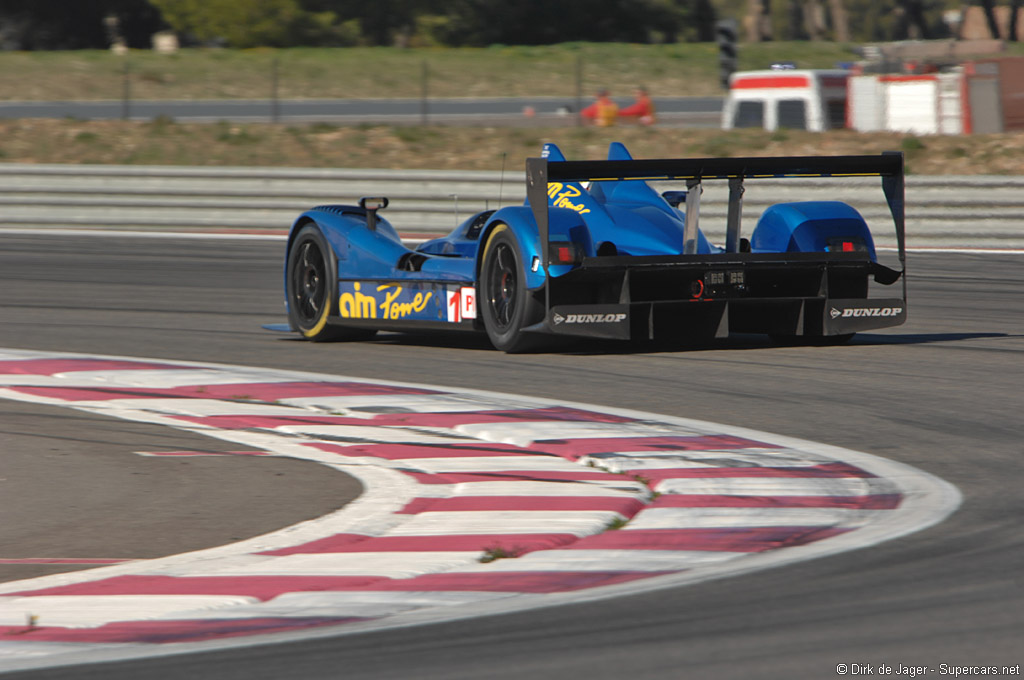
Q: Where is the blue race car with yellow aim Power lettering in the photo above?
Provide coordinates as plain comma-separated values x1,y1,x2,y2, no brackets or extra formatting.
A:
285,142,906,352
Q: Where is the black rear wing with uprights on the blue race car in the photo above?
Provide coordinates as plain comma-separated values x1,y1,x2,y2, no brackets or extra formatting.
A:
526,152,906,288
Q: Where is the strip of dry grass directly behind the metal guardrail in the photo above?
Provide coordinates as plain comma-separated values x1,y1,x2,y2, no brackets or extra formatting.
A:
0,119,1024,174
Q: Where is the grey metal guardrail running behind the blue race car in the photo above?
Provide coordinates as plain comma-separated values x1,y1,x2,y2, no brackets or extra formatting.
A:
0,164,1024,248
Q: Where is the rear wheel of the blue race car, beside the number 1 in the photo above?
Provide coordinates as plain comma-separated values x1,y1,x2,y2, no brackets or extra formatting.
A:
480,224,544,353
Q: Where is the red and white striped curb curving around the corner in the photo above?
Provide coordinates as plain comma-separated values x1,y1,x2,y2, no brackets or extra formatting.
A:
0,349,959,671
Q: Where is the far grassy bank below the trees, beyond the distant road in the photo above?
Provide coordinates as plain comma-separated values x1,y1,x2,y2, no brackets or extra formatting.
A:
0,42,854,100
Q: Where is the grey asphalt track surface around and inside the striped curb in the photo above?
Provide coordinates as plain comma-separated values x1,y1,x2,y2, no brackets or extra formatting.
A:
0,235,1024,680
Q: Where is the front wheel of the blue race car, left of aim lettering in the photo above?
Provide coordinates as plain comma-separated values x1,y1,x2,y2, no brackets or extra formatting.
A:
285,224,377,342
